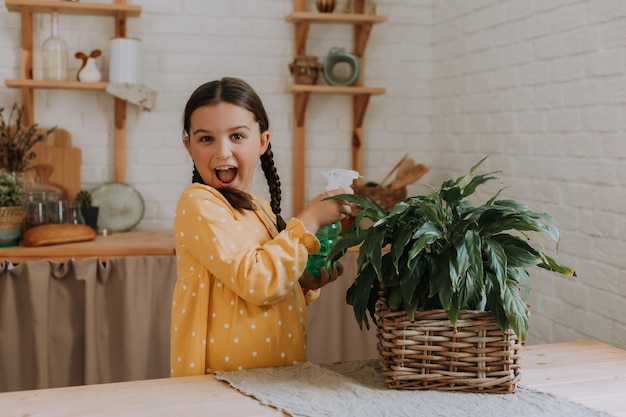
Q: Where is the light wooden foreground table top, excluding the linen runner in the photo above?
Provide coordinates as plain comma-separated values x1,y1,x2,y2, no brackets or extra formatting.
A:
0,341,626,417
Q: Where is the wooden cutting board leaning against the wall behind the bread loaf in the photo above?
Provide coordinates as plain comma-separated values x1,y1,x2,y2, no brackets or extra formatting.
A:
26,128,81,200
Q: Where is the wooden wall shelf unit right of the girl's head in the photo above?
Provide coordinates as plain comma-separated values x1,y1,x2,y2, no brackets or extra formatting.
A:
285,0,387,214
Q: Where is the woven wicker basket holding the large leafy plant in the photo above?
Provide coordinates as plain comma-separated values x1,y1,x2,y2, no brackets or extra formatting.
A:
376,297,521,394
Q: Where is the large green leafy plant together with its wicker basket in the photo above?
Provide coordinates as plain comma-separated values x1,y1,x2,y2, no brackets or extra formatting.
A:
326,157,575,392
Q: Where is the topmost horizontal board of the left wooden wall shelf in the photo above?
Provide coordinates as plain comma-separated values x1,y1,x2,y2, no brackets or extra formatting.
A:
4,0,141,17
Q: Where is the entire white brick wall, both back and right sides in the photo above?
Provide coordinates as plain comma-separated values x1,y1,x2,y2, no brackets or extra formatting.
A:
0,0,626,347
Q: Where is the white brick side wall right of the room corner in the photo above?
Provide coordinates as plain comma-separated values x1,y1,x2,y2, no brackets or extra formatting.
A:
430,0,626,347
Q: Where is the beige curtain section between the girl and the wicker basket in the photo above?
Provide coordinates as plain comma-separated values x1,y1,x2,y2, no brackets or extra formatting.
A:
307,252,378,363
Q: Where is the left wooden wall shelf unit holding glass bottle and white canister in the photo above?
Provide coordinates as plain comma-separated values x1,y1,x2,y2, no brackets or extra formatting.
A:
4,0,141,182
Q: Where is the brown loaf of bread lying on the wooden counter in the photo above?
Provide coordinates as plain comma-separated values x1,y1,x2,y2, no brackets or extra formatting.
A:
22,224,98,246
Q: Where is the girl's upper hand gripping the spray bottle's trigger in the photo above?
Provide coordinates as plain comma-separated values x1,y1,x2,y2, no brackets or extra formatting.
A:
296,187,354,233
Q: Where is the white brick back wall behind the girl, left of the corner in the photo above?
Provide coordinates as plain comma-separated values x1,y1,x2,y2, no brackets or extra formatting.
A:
0,0,431,224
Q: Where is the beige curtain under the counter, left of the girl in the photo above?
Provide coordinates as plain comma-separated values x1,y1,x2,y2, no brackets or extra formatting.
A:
0,256,176,391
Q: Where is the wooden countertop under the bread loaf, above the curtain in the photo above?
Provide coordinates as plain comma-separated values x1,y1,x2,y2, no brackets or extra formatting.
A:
0,230,174,263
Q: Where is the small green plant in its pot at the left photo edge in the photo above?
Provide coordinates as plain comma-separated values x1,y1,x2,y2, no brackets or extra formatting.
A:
0,169,24,247
